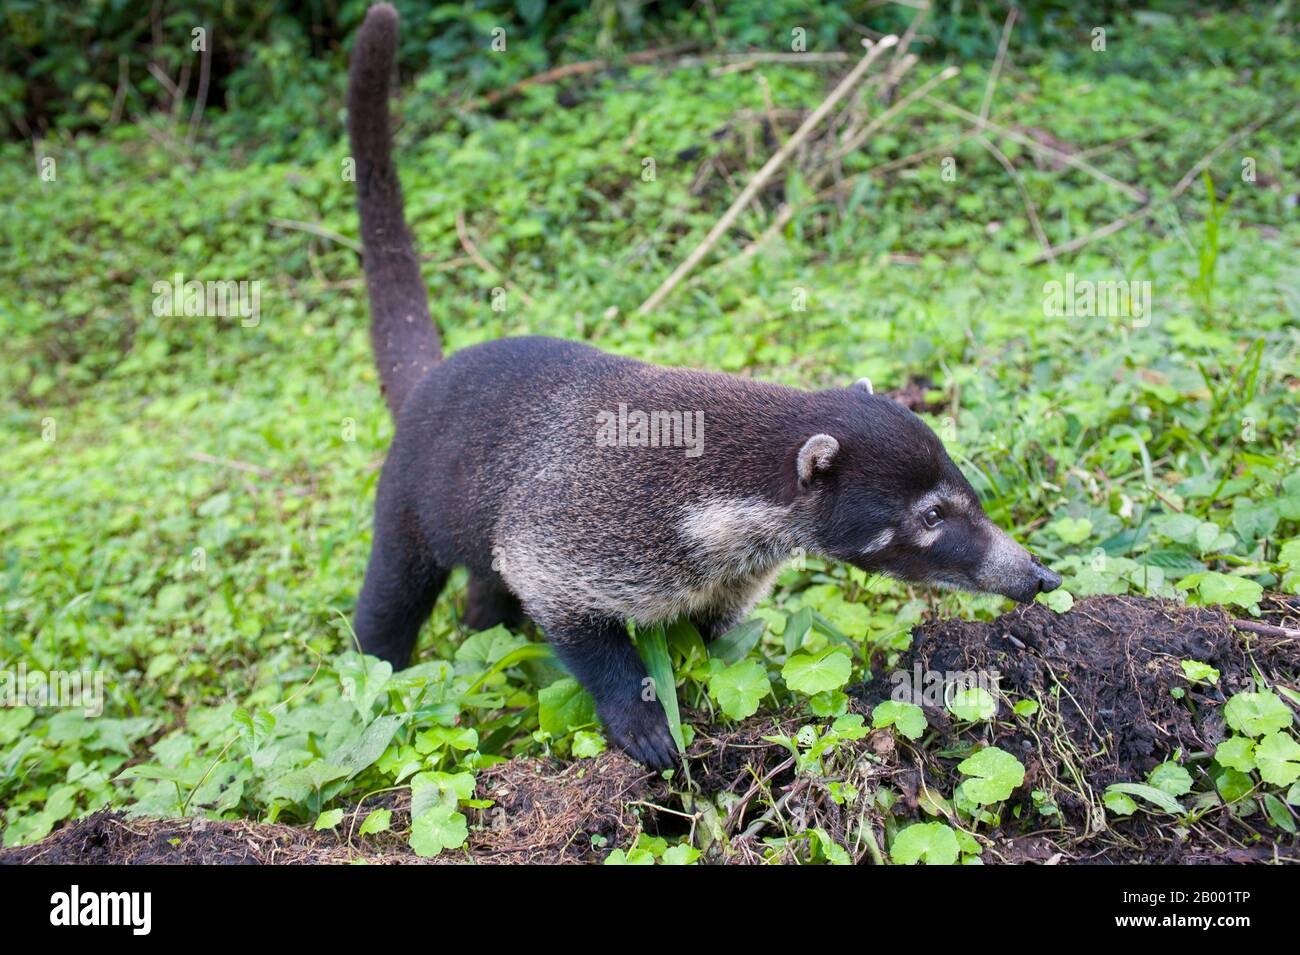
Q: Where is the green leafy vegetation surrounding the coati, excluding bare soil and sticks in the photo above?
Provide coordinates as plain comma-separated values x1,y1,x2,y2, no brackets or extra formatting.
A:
0,0,1300,862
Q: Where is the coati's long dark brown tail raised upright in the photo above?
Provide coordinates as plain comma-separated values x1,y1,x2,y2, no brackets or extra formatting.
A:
347,4,442,414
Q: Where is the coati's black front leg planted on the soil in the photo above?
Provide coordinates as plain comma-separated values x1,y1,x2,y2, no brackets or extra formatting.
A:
534,615,677,769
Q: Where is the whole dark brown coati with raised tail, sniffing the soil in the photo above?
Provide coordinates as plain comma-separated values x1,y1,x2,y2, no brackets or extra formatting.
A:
347,4,1061,769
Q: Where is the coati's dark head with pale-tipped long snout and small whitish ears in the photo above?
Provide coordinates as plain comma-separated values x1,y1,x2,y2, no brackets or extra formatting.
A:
798,394,1061,603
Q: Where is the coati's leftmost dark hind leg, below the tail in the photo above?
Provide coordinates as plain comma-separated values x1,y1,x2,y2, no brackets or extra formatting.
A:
355,529,447,669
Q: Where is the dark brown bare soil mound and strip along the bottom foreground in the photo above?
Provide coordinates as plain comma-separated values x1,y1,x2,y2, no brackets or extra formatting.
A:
0,595,1300,864
